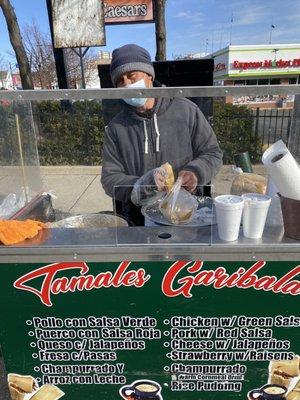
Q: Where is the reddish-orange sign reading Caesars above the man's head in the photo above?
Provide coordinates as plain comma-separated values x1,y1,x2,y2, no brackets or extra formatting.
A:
104,0,154,25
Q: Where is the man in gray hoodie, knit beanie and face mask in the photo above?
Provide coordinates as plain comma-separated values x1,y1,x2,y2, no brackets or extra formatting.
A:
101,44,222,225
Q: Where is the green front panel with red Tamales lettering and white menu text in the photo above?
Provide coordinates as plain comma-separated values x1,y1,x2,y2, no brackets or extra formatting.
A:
0,261,300,400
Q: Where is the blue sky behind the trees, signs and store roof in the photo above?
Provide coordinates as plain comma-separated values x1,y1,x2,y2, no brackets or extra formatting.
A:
0,0,300,65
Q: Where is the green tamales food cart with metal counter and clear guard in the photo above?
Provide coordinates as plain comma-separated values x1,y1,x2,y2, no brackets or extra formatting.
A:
0,85,300,400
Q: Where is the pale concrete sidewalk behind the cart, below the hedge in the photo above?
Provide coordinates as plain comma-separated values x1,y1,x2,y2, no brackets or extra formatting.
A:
41,165,266,214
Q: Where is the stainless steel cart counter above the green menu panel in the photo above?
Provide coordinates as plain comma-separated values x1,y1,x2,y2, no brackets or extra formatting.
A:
0,226,300,262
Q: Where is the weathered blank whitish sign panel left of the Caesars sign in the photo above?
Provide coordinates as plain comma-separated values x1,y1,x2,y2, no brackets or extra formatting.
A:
52,0,105,48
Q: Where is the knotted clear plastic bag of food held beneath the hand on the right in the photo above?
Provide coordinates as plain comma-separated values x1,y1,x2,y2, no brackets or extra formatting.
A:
159,178,198,225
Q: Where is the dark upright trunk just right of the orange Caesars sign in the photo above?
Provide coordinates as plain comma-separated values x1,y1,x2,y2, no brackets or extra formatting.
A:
153,0,167,61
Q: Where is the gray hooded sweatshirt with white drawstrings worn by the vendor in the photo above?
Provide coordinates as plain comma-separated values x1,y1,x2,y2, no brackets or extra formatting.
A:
101,98,222,203
